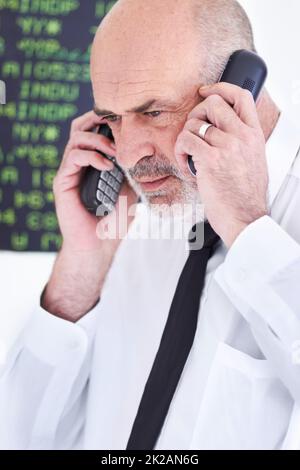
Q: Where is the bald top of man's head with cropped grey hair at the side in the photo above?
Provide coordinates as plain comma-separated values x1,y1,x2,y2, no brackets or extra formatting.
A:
93,0,255,90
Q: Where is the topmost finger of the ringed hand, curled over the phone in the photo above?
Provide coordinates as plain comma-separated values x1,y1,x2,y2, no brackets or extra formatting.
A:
199,82,260,128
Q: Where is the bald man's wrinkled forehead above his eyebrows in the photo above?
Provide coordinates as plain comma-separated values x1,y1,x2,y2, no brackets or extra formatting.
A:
91,29,199,112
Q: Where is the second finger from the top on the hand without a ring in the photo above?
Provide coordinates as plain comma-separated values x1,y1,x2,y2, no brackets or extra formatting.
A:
68,131,116,157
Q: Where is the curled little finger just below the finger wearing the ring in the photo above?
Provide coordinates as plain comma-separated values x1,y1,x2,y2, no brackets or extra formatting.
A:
174,130,213,174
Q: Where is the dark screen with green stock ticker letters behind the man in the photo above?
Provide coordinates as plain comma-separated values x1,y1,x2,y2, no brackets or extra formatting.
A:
0,0,116,252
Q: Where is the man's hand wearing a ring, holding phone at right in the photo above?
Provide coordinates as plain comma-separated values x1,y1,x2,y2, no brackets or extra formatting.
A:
175,82,268,248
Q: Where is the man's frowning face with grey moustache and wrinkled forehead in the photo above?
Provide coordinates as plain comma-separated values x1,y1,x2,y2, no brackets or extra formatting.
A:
91,0,201,205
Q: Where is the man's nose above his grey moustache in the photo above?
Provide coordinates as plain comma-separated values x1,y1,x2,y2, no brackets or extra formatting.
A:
115,116,155,169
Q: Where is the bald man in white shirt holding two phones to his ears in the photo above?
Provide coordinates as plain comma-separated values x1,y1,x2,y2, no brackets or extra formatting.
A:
1,0,300,449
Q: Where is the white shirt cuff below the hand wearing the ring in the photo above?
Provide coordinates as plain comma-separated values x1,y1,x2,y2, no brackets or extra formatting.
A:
215,216,300,347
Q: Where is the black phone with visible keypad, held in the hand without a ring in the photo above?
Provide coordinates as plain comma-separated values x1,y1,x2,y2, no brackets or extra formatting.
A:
80,124,125,216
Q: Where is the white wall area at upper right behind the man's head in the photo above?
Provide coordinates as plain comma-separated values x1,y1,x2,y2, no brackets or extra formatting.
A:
240,0,300,122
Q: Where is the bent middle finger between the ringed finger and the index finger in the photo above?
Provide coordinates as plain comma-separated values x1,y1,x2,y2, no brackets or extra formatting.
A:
188,95,246,137
